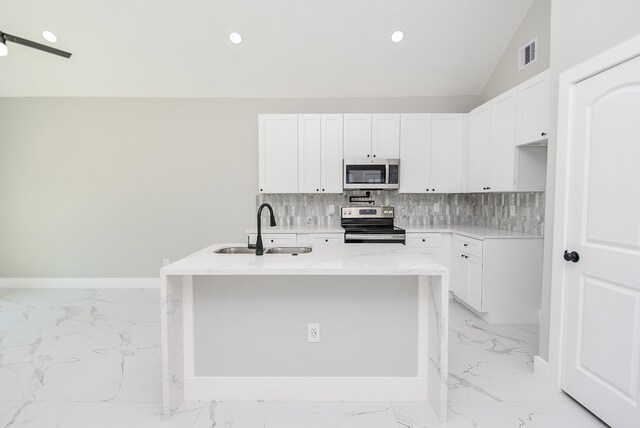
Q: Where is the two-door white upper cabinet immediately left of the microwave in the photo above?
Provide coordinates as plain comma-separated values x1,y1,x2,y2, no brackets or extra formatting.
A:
298,114,342,193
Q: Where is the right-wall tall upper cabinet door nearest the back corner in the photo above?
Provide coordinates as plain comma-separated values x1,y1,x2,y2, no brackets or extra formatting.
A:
467,104,491,192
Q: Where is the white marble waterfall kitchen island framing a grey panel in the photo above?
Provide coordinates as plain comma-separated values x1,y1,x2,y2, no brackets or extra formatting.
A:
161,244,449,422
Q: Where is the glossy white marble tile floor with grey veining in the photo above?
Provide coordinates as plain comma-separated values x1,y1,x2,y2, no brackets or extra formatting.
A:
0,289,606,428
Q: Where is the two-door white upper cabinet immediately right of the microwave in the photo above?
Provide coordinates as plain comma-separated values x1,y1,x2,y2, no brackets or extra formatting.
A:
400,114,466,193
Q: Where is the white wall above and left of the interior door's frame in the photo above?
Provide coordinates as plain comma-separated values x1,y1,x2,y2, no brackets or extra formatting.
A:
540,0,640,359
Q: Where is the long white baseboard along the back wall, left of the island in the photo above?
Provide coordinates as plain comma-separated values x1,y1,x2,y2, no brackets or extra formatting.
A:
0,277,160,288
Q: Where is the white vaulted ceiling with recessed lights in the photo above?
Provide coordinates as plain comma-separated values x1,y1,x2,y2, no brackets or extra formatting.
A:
0,0,533,97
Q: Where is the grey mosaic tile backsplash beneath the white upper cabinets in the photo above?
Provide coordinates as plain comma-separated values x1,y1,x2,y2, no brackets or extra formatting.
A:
256,191,544,235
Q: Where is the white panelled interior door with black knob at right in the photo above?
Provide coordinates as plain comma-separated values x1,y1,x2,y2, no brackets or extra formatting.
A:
562,53,640,428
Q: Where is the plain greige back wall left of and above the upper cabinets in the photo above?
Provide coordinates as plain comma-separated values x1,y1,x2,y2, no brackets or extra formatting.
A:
0,96,479,278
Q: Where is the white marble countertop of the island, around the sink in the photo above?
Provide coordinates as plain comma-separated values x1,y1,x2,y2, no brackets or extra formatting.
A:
160,244,448,276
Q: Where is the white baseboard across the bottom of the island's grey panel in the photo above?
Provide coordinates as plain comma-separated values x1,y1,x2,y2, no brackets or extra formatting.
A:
184,376,427,401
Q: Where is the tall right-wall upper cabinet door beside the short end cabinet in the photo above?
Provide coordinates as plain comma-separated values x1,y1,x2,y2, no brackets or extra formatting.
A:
490,90,518,192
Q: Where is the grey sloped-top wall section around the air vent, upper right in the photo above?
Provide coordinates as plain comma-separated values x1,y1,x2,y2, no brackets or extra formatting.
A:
482,0,551,102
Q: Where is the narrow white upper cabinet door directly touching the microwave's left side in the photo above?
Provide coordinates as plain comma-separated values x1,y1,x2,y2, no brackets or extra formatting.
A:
320,114,343,193
